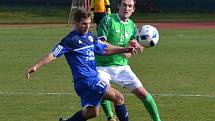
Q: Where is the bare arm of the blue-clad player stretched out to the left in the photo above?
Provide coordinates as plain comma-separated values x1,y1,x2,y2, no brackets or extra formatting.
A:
25,53,56,79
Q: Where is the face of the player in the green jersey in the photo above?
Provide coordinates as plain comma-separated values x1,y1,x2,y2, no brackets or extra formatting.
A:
119,0,135,21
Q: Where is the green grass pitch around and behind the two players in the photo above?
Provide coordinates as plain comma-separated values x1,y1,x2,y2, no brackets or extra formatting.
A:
0,25,215,121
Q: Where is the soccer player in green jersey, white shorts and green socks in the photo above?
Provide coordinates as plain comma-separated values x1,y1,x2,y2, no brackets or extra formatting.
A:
96,0,160,121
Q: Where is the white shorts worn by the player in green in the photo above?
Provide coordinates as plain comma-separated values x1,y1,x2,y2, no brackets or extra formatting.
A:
97,66,142,91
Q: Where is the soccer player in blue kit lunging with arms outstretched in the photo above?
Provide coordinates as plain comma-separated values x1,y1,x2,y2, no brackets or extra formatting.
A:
26,10,136,121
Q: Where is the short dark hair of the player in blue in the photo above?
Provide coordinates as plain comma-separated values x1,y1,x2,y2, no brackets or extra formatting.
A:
73,9,90,22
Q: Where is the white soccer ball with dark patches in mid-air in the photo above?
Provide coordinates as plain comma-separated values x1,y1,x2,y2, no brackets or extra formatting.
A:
137,25,159,48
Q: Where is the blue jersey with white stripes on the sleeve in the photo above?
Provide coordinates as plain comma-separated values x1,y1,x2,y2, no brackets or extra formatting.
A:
52,29,107,81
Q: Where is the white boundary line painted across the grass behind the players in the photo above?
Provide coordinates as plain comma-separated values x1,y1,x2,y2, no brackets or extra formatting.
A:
0,91,215,98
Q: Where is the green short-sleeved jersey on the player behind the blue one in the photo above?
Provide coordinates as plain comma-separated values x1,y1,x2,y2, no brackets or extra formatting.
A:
96,14,136,66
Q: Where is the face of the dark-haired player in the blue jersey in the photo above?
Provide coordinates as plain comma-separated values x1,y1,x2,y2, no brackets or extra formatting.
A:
75,17,91,34
